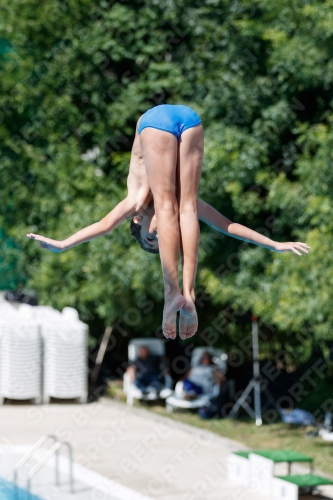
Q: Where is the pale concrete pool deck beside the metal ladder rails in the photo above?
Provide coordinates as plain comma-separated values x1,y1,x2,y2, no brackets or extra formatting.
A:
0,399,333,500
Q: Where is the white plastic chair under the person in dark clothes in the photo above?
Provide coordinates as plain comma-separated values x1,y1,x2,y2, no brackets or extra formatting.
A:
123,338,173,406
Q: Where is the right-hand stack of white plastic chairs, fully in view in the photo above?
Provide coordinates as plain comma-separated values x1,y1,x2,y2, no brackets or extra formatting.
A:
41,307,88,403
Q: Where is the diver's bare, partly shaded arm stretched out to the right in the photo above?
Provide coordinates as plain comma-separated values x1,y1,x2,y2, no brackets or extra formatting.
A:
198,200,310,255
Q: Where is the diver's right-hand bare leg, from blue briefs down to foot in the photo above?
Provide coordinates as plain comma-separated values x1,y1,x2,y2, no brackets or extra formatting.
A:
177,124,204,339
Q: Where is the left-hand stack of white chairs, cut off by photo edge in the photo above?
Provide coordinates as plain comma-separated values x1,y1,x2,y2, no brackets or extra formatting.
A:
0,302,42,404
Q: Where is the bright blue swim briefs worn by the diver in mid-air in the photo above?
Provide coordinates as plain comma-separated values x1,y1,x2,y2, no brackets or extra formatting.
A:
138,104,201,141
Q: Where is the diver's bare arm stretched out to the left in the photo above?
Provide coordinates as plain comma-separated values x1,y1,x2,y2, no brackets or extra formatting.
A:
27,197,137,253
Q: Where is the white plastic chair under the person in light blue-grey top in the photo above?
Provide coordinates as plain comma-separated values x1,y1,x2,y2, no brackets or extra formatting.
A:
166,347,228,413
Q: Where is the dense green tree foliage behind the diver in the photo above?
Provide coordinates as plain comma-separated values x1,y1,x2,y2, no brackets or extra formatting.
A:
0,0,333,359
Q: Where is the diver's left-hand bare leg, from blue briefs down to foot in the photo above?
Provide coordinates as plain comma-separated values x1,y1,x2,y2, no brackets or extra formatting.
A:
140,128,185,339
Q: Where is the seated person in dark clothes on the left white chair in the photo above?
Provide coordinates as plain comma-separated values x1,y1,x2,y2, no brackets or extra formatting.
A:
127,346,163,394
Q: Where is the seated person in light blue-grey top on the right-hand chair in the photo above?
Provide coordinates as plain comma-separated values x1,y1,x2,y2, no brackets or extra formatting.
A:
183,351,223,399
